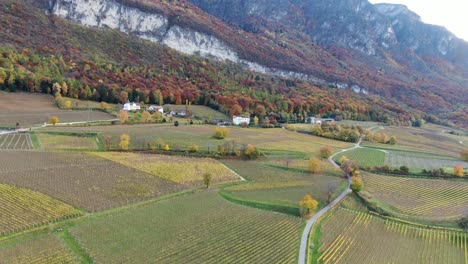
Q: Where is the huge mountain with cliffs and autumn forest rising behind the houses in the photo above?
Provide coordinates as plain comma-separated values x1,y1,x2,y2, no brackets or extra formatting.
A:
0,0,468,124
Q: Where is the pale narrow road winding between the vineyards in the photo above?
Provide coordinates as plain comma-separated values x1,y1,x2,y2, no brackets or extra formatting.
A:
298,130,377,264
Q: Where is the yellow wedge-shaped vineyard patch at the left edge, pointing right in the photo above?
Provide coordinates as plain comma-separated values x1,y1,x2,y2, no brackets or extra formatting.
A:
0,184,81,235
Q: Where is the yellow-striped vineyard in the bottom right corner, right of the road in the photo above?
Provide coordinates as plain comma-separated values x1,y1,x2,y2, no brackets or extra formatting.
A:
317,208,468,264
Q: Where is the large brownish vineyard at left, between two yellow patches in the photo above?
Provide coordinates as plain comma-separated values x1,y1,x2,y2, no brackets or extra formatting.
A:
0,151,187,211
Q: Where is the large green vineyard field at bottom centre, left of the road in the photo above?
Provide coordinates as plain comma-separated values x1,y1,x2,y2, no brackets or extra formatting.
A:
71,191,302,263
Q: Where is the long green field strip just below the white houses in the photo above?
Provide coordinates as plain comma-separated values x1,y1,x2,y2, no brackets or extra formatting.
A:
40,124,351,155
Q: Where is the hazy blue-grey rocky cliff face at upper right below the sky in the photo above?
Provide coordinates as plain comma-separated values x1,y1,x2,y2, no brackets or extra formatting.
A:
190,0,468,66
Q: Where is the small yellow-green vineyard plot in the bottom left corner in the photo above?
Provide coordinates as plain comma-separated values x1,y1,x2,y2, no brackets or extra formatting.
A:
0,235,78,264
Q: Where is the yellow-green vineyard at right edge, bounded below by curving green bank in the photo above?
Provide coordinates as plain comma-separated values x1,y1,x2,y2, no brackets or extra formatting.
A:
363,173,468,220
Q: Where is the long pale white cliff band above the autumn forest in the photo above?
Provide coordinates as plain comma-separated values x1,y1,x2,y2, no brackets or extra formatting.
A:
48,0,330,83
